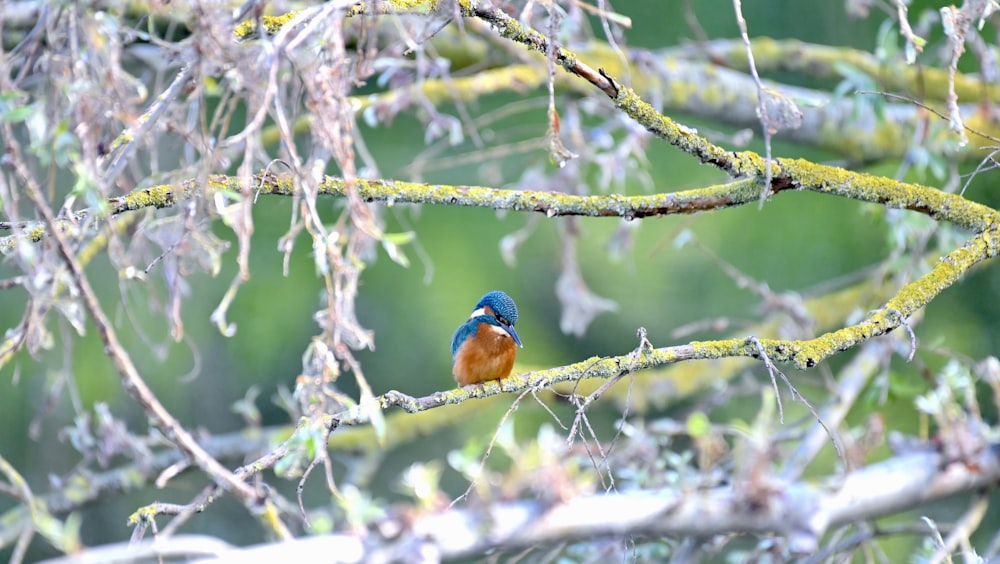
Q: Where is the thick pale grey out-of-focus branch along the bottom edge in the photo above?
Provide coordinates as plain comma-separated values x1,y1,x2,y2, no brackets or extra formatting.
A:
50,445,1000,561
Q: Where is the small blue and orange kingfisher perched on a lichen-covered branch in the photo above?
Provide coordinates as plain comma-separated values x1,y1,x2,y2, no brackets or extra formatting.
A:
451,290,524,386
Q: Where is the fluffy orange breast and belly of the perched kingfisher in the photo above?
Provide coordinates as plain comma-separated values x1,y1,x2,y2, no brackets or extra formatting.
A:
451,323,517,386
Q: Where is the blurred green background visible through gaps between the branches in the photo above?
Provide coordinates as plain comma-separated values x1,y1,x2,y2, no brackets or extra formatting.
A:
0,0,1000,557
